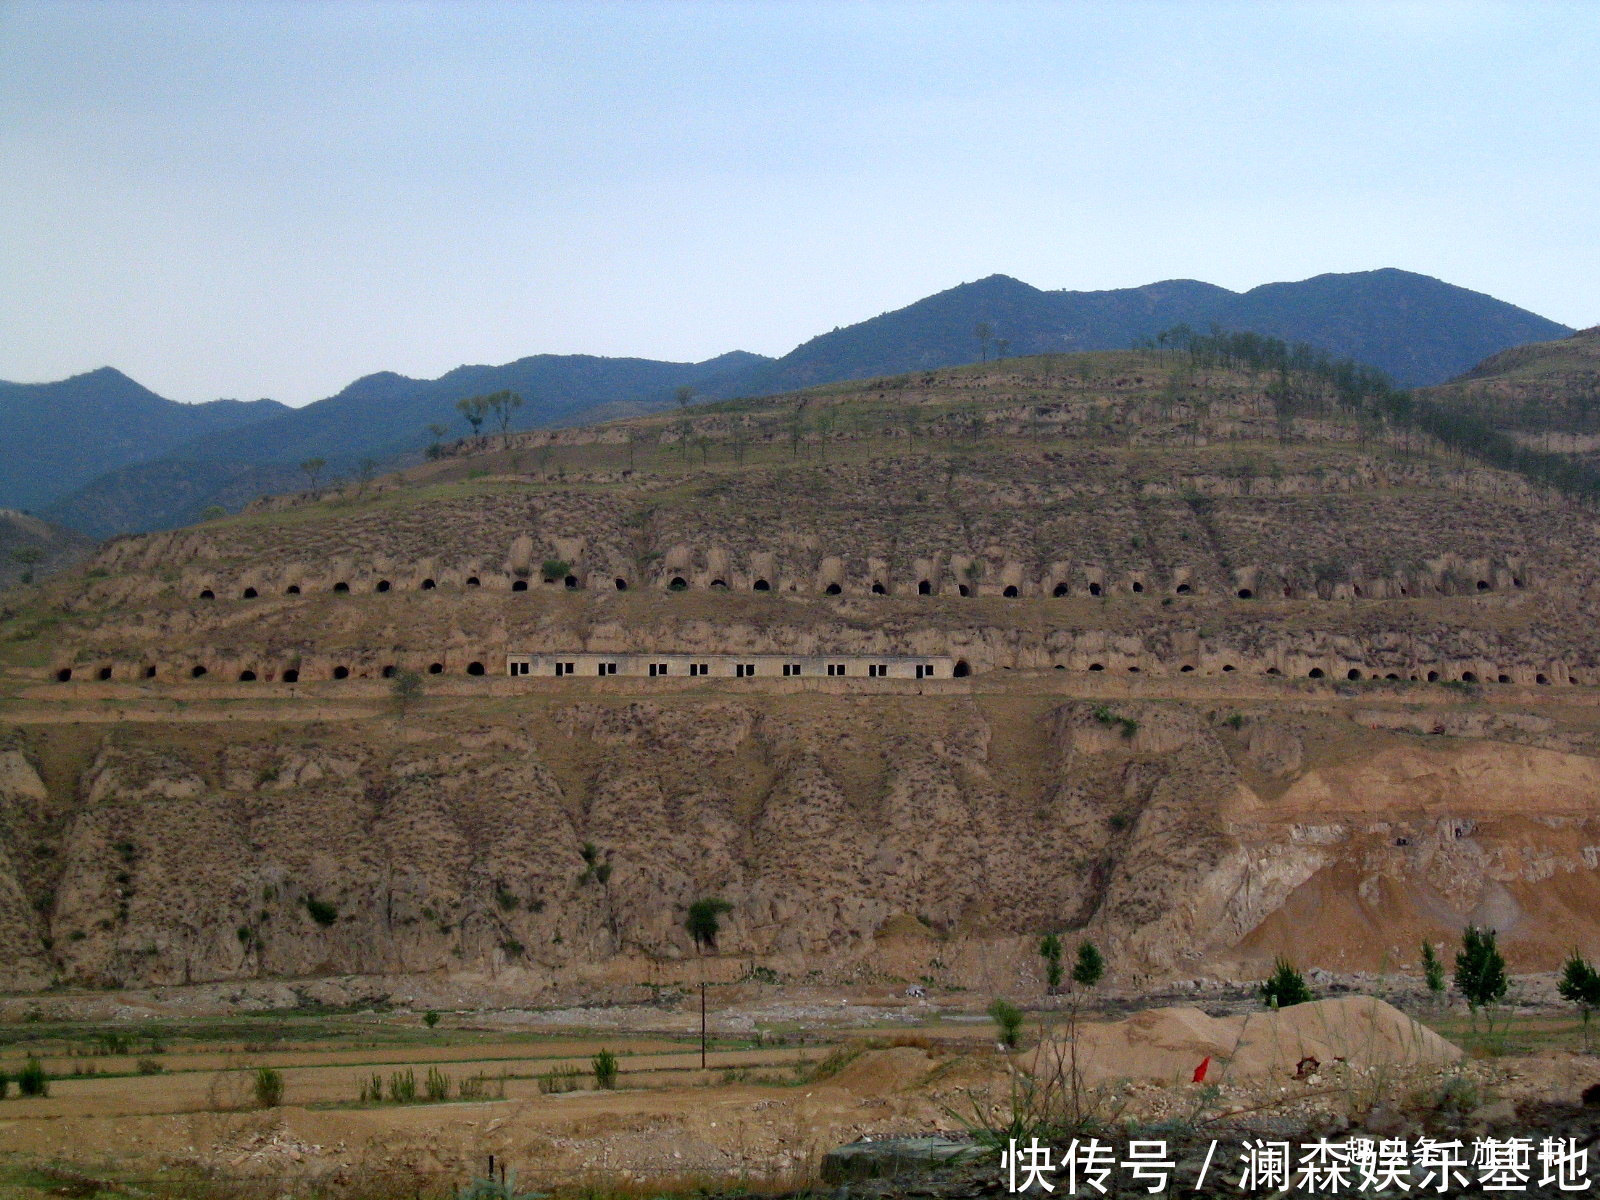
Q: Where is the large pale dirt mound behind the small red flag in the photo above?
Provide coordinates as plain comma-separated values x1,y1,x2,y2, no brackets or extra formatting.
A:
1061,995,1461,1083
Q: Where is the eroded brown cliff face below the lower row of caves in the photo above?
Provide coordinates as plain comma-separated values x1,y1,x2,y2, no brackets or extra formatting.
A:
0,694,1600,989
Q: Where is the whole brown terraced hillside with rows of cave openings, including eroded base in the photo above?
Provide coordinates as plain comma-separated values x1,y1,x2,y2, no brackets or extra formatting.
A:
0,354,1600,986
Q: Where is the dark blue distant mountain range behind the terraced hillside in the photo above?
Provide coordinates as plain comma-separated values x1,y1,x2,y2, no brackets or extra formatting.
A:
0,269,1571,536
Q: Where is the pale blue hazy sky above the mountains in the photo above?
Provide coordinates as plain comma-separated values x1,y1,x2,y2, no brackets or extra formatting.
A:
0,0,1600,403
